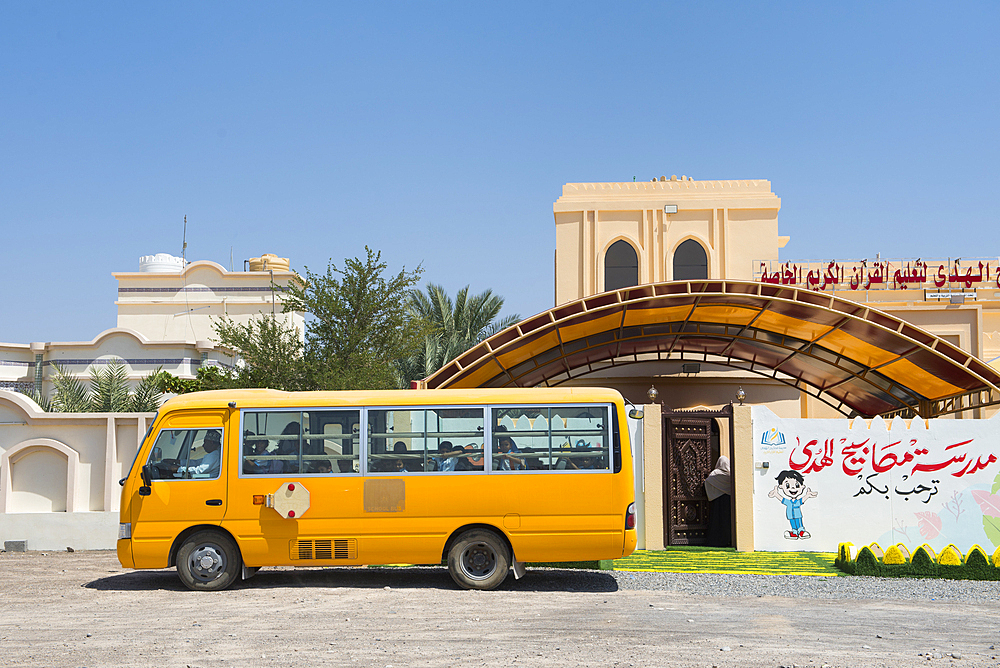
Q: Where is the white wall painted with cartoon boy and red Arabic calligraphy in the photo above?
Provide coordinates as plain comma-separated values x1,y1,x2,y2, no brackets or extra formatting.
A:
751,406,1000,554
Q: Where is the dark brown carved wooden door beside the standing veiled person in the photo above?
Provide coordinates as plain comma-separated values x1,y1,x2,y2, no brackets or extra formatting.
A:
663,417,712,545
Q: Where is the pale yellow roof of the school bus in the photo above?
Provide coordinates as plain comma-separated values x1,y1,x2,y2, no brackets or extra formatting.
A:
160,387,623,412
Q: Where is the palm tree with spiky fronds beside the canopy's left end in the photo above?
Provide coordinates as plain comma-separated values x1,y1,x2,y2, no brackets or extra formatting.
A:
400,283,521,384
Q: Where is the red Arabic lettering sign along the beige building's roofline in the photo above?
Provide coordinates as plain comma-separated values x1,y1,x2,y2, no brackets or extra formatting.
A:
754,257,1000,291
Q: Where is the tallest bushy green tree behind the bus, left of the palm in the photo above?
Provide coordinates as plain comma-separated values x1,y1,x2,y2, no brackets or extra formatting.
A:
284,246,424,390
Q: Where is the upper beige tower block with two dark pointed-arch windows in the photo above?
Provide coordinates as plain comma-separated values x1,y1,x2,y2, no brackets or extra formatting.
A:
553,176,788,306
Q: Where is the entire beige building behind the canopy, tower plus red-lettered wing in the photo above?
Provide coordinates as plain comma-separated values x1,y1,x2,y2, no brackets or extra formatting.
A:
553,176,1000,417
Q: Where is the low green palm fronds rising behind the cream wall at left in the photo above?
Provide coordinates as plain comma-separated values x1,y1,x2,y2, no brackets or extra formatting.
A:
39,359,163,413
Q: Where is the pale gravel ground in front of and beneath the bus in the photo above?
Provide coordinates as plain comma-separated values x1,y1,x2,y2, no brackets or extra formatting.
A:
0,552,1000,668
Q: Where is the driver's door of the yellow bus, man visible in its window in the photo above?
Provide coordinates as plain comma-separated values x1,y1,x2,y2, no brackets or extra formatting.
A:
131,410,228,568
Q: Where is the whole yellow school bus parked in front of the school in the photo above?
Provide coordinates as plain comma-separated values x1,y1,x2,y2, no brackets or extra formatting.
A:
118,387,636,590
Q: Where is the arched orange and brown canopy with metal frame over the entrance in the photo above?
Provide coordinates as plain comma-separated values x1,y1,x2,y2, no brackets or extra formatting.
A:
424,281,1000,417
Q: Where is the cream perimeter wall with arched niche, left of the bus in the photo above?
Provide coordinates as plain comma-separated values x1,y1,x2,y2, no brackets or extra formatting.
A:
0,390,153,550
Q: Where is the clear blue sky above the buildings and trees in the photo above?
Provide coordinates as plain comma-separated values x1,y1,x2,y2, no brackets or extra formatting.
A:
0,0,1000,343
